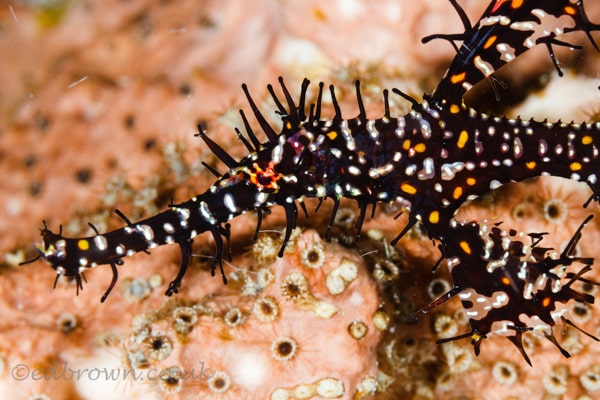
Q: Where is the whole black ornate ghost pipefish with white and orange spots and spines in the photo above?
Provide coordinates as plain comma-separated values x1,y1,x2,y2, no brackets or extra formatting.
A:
21,0,600,361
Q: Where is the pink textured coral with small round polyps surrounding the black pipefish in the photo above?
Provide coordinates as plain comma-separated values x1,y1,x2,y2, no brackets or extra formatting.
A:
0,0,600,399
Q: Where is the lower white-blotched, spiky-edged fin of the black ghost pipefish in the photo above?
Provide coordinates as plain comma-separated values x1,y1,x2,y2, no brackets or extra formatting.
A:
409,215,599,365
